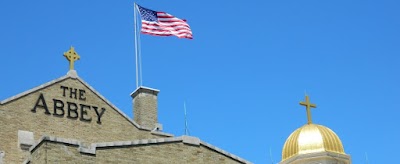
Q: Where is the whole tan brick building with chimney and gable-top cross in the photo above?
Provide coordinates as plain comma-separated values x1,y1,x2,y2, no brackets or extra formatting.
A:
0,48,250,164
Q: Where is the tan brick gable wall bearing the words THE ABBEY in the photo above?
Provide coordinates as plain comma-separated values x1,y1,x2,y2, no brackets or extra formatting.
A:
0,74,171,162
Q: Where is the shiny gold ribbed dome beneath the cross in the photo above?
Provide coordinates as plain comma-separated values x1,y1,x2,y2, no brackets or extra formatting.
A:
282,123,345,161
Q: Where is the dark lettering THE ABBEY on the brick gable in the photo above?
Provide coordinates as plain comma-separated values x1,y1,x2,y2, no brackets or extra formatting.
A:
31,86,106,124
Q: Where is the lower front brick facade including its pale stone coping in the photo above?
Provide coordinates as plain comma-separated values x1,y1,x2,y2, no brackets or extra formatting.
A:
24,136,248,164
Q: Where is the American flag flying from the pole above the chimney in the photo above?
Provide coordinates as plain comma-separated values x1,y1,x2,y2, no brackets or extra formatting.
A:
137,5,193,39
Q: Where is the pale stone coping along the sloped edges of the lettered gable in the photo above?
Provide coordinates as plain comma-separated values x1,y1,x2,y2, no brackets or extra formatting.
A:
0,70,173,137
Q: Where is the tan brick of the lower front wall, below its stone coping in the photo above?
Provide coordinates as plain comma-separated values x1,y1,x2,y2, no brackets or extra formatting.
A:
29,138,242,164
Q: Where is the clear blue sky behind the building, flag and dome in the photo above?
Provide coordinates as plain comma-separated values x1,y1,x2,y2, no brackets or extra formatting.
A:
0,0,400,164
